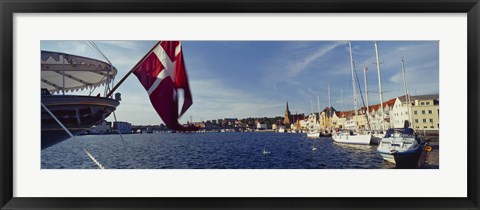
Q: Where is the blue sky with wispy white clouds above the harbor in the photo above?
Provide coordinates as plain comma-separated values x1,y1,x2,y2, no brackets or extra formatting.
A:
41,41,439,124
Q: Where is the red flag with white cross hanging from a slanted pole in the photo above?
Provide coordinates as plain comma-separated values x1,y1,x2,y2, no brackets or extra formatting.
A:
133,41,193,130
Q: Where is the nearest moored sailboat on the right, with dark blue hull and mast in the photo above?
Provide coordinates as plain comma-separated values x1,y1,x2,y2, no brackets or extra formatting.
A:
377,59,425,168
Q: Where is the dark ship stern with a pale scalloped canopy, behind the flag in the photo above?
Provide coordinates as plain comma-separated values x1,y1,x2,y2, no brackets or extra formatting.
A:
40,51,120,150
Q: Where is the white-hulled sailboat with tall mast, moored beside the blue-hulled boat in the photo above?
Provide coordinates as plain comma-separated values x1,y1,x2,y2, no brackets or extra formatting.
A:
332,42,372,144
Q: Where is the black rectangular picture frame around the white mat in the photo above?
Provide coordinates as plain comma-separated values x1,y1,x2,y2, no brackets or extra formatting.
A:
0,0,480,209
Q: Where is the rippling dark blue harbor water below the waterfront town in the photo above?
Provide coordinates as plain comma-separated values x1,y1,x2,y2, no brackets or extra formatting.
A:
41,132,406,169
